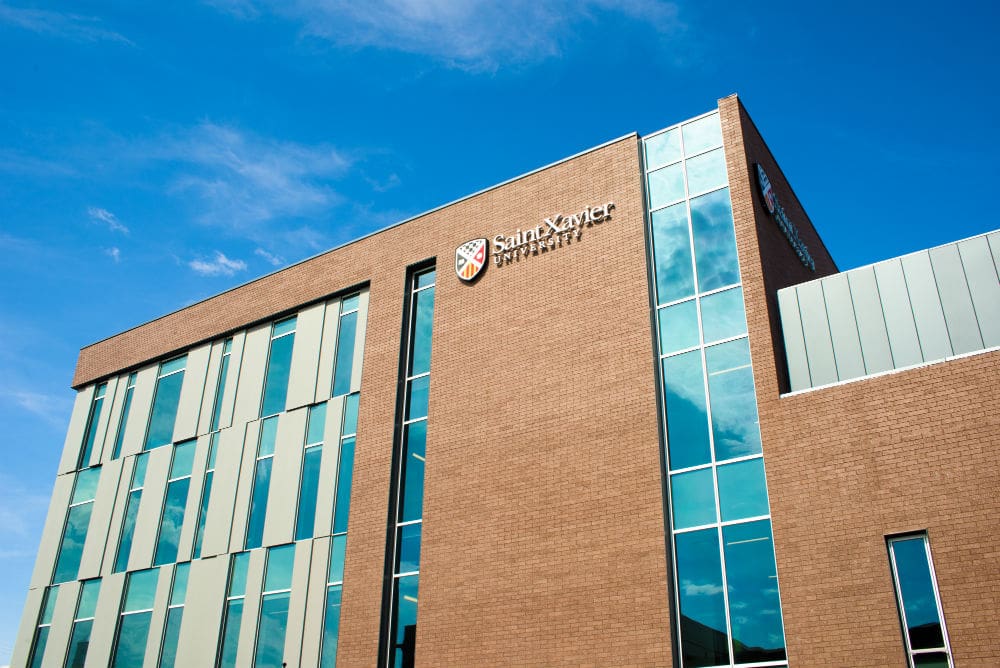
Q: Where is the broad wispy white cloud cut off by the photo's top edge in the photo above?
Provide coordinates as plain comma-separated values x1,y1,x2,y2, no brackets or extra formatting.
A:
209,0,683,71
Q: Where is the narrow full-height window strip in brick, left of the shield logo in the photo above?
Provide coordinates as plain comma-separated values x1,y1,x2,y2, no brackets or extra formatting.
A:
382,268,435,668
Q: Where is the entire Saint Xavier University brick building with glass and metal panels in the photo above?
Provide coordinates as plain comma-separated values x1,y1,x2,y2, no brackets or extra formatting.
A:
13,96,1000,668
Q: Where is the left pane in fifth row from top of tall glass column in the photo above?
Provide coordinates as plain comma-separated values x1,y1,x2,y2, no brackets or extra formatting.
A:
663,350,711,470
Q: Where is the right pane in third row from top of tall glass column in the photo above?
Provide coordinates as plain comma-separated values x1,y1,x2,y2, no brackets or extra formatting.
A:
691,188,740,292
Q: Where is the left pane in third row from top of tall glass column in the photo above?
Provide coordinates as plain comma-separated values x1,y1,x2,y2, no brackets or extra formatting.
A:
651,202,694,304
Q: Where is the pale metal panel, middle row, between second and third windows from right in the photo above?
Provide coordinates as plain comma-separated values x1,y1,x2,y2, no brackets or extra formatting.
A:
264,408,304,546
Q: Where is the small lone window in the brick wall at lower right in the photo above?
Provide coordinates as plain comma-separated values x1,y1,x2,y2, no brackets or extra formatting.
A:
888,534,954,668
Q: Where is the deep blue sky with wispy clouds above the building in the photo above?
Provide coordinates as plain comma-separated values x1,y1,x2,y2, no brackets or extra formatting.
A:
0,0,1000,665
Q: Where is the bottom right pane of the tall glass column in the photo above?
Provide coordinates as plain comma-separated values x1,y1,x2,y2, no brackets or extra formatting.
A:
722,520,785,663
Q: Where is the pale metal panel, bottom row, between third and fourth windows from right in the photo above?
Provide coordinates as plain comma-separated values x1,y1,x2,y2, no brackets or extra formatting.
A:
175,555,229,668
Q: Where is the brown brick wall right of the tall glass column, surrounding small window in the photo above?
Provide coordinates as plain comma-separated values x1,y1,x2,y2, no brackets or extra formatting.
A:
720,98,1000,666
